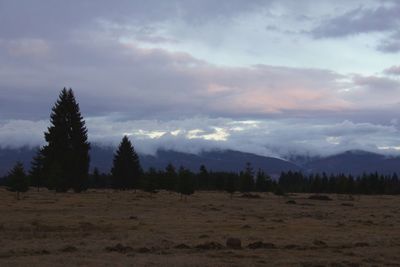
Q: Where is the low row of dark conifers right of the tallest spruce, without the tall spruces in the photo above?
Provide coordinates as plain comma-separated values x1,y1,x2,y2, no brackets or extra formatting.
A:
59,163,400,195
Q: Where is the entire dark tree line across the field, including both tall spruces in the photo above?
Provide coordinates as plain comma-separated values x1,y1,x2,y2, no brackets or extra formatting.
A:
3,88,400,199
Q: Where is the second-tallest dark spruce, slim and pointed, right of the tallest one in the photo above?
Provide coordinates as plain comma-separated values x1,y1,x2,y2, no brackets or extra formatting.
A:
111,136,142,190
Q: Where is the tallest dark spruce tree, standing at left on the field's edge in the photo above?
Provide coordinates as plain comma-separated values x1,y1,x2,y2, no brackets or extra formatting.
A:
40,88,90,192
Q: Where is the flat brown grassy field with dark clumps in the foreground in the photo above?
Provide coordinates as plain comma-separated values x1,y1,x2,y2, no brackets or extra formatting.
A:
0,189,400,266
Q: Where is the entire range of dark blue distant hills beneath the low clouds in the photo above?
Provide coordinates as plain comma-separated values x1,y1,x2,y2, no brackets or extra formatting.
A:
0,145,400,176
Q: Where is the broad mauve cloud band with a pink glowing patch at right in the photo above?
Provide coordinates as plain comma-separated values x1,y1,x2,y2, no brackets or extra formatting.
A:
0,32,349,121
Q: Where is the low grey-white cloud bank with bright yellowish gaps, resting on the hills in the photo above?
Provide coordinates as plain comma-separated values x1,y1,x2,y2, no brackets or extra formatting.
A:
0,117,400,158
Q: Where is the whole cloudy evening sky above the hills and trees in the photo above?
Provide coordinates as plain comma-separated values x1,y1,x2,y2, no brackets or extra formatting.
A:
0,0,400,158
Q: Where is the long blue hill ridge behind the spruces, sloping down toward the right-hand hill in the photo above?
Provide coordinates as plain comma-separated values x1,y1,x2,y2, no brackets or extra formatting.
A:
0,146,301,176
